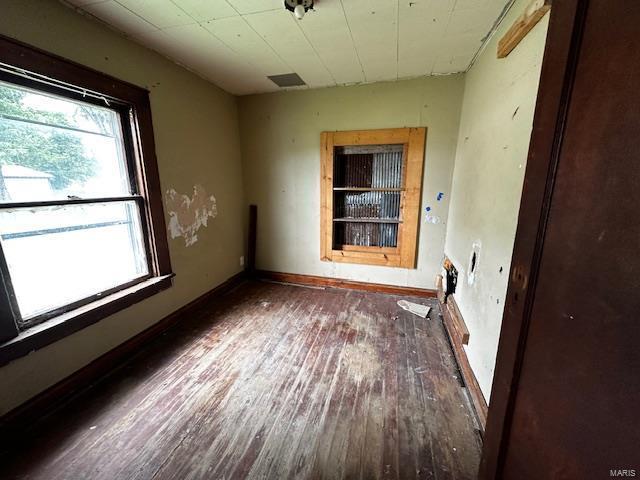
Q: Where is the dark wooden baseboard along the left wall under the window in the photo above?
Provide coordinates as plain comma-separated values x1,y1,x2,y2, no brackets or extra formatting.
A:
0,272,246,438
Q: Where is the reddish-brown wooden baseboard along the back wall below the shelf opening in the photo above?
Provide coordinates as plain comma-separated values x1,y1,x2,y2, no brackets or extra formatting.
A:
255,270,436,298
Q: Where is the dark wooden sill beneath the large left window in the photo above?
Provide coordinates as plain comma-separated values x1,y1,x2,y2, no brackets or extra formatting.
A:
0,274,174,366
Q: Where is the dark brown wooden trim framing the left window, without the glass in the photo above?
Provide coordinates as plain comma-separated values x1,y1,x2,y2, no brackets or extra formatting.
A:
0,35,173,354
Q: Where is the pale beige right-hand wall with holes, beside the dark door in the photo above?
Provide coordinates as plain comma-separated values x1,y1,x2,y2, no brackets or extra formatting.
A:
445,0,548,400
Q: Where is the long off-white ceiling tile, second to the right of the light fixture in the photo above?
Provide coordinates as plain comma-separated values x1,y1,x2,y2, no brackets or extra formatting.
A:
342,0,398,82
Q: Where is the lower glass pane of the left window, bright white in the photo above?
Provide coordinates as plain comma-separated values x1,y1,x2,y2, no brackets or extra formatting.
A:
0,201,148,319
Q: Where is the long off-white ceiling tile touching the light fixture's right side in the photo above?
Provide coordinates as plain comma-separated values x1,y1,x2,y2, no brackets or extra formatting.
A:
298,1,364,84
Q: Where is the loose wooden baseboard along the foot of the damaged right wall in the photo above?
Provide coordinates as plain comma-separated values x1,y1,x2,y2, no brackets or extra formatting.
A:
441,295,489,434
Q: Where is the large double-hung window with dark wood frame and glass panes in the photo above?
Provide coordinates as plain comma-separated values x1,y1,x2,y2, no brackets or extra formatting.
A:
0,34,171,356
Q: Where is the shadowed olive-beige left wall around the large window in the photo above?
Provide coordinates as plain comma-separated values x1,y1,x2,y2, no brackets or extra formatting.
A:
0,0,246,415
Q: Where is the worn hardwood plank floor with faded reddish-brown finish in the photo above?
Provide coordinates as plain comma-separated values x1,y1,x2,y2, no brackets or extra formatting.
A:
0,282,480,480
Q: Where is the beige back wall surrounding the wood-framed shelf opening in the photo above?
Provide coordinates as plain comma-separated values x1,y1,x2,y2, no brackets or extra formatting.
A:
239,75,464,288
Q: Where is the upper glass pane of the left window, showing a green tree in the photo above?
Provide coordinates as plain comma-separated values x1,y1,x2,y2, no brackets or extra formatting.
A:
0,82,130,202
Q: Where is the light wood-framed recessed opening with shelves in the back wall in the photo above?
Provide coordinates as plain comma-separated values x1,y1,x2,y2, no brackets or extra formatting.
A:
320,128,426,268
